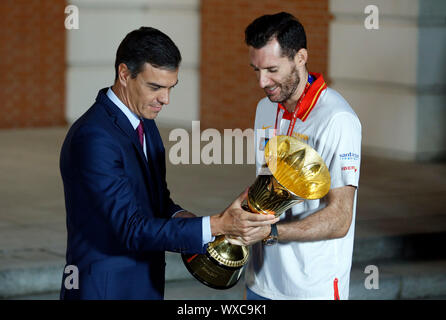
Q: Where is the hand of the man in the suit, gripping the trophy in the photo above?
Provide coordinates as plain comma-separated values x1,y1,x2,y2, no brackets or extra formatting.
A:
210,189,279,242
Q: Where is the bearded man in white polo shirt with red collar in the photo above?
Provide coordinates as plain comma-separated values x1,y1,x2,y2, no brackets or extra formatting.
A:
240,12,361,299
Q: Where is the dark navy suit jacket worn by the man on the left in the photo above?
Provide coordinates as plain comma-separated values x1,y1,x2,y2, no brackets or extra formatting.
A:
60,88,205,299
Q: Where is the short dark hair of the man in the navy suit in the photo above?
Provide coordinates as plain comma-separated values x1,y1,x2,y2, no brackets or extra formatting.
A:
115,27,181,81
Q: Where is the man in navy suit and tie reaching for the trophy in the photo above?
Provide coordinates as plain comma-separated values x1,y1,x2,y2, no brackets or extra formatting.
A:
60,27,277,299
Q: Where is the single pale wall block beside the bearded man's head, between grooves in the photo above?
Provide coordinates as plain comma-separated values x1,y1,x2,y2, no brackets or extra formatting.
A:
329,21,418,86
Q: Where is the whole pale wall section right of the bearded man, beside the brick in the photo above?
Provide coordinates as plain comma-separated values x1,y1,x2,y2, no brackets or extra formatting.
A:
329,0,428,160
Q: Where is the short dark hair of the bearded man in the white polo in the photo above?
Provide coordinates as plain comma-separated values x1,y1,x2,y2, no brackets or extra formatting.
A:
245,12,307,59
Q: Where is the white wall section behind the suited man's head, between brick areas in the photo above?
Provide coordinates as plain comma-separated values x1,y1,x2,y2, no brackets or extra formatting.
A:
66,0,200,128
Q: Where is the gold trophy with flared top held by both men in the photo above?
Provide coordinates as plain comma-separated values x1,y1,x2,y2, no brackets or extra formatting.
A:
182,136,330,289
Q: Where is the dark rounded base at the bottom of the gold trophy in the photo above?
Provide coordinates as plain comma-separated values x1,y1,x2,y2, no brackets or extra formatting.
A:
181,252,243,290
